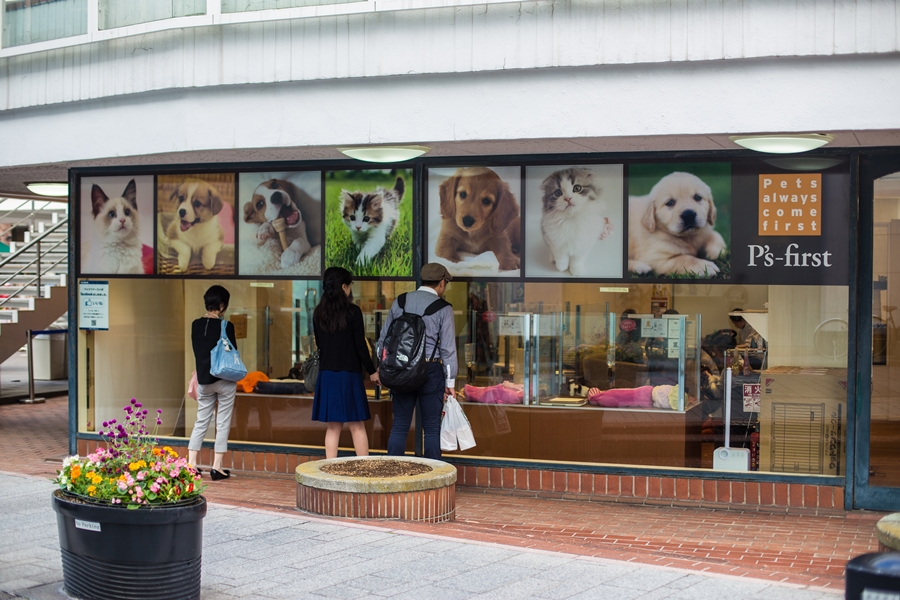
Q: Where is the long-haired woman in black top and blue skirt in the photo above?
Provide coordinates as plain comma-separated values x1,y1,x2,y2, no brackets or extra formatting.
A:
312,267,377,458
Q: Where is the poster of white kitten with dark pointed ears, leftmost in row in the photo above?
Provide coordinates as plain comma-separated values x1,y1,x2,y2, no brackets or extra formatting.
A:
78,175,154,275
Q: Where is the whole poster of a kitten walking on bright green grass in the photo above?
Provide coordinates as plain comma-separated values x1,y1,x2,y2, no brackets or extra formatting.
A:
325,169,414,278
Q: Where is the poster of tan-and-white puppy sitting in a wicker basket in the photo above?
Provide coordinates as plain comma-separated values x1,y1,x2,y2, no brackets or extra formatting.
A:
156,173,235,275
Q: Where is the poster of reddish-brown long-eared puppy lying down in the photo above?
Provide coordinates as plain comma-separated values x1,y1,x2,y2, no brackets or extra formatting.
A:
427,167,522,277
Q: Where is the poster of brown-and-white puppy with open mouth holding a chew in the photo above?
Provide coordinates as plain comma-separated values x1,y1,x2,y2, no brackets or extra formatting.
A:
237,171,322,276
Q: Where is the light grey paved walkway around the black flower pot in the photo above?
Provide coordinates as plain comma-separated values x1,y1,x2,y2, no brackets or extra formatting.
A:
0,473,839,600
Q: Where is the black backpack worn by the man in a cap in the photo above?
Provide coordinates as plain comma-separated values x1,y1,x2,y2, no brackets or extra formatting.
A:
378,294,450,392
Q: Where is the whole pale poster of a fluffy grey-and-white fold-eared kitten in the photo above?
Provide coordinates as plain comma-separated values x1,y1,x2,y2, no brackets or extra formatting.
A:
525,165,625,279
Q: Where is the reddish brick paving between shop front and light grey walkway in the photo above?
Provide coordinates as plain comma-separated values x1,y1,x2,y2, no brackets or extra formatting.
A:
0,398,883,590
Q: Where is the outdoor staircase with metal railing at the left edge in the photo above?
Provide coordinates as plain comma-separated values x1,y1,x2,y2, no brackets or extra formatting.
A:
0,200,69,362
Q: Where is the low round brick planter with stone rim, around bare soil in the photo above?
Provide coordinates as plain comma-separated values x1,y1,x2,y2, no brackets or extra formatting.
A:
296,456,456,523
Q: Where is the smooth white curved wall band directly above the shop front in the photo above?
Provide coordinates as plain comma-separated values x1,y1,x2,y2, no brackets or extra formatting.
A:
0,57,900,167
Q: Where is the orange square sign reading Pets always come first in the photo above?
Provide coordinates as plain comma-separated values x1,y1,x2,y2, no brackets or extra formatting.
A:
759,173,822,236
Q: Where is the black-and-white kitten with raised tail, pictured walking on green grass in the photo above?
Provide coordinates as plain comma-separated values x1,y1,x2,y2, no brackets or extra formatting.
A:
341,177,405,264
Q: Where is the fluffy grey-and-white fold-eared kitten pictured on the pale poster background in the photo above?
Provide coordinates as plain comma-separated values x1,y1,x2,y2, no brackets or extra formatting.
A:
541,168,612,277
